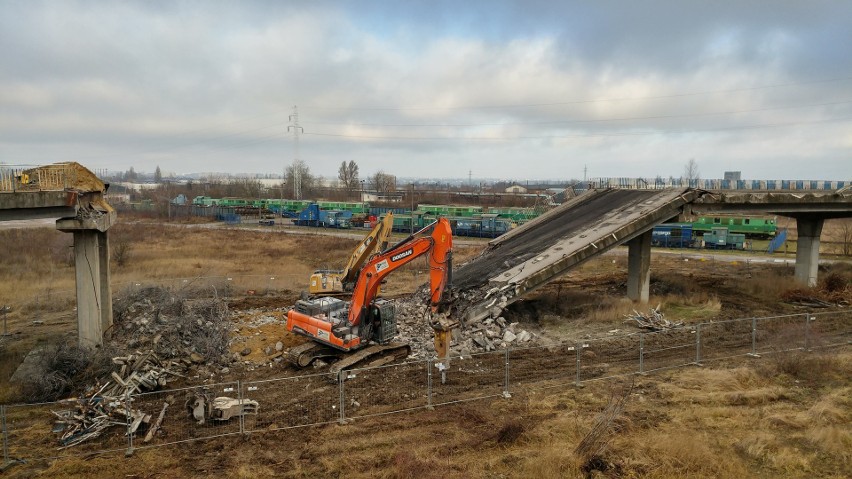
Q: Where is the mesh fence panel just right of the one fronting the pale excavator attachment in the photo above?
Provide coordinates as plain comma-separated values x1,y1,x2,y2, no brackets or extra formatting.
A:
242,374,341,432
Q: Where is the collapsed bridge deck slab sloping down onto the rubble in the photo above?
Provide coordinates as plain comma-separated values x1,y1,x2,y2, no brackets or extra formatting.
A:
453,188,702,319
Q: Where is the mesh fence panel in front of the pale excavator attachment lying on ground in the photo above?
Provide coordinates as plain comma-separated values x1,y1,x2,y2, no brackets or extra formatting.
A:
131,382,240,449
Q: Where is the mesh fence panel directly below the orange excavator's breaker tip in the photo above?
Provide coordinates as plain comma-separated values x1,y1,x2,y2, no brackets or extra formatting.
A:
432,351,506,405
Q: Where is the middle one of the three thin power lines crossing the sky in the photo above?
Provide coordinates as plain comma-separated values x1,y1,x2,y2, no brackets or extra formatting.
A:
300,100,852,128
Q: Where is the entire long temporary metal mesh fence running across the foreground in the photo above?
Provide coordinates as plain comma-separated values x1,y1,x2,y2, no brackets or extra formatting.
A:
0,311,852,462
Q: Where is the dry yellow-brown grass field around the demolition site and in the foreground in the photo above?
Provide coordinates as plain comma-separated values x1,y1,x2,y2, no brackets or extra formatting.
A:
0,216,852,478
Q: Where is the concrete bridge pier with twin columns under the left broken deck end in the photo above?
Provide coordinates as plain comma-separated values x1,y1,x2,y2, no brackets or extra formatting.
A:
56,212,115,347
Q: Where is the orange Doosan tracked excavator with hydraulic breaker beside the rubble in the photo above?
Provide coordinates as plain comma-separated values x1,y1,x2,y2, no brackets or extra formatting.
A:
287,218,457,373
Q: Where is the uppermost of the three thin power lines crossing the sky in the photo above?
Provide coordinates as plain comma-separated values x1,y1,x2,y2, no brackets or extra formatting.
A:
294,76,852,111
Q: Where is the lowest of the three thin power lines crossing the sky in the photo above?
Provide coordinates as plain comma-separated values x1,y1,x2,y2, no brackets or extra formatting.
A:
302,117,852,141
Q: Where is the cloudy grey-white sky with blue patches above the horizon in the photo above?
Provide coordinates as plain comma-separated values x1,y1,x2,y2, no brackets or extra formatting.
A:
0,0,852,180
